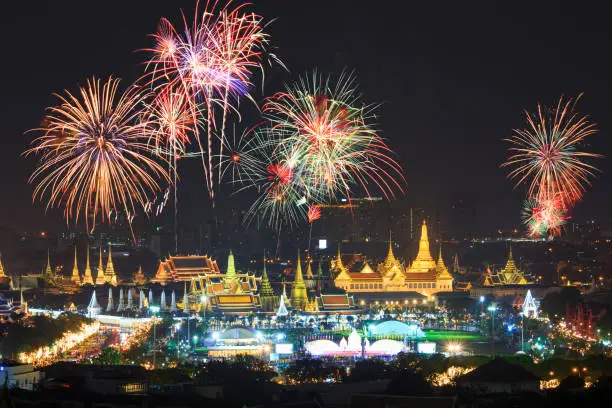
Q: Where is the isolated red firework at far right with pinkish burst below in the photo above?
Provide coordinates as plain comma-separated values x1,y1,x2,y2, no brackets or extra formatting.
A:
502,96,602,236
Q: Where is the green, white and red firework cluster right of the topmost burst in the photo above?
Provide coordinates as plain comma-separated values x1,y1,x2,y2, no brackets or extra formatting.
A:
223,74,404,229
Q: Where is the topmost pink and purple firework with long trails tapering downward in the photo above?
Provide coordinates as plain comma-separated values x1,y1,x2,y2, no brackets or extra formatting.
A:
143,1,276,200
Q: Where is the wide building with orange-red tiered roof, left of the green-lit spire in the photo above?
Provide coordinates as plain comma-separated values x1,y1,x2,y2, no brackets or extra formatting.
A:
151,255,221,285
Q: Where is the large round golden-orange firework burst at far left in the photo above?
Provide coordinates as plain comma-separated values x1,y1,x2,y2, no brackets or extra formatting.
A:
25,78,169,230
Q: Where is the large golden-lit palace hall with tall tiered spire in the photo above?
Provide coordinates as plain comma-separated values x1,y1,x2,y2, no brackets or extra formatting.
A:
332,221,453,296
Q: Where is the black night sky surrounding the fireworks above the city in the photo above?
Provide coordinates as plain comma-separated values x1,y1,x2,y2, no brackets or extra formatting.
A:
0,0,612,231
